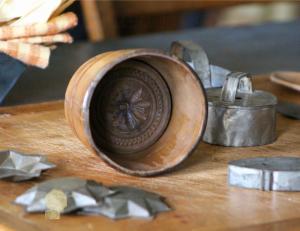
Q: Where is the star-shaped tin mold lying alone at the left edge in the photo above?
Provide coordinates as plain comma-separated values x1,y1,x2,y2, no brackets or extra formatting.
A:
0,150,55,181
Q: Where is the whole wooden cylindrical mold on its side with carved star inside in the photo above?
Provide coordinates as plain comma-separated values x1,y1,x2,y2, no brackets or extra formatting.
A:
65,49,207,176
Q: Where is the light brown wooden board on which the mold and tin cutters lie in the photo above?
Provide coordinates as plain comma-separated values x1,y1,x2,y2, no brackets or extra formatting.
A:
0,75,300,231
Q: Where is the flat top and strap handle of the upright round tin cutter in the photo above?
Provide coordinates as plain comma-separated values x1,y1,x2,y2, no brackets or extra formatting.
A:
206,72,277,109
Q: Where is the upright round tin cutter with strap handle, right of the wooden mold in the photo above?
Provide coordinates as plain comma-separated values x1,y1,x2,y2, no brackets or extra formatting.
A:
203,72,277,147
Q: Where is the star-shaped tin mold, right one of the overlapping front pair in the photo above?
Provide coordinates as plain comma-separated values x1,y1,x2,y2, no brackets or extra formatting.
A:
80,186,171,219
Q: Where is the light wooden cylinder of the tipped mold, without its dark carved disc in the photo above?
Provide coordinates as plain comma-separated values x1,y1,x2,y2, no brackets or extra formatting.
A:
65,49,207,176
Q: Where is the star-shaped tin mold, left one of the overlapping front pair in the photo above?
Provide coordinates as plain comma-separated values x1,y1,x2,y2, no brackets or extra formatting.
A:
14,177,114,213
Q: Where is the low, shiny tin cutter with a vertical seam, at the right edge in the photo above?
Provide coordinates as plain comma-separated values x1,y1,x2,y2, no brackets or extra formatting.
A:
228,157,300,191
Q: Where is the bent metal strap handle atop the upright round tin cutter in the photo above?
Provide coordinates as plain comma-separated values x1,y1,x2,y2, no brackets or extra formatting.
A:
221,72,253,103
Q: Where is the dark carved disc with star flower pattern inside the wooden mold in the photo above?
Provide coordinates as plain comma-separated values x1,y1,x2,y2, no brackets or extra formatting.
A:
92,61,171,154
